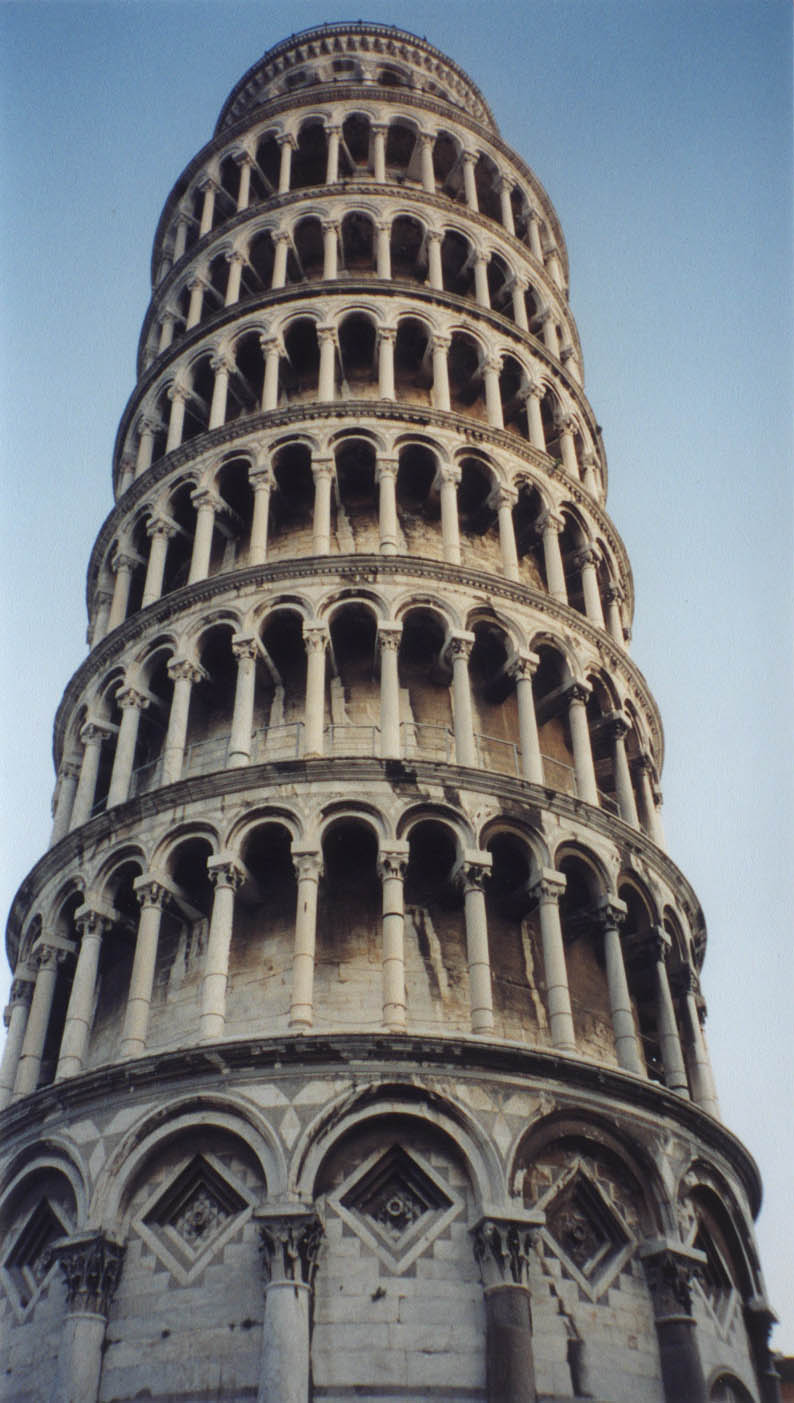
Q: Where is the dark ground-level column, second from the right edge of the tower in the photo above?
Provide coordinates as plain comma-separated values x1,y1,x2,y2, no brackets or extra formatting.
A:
640,1242,708,1403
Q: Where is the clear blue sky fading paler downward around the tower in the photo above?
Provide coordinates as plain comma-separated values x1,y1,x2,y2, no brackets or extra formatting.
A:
0,0,794,1352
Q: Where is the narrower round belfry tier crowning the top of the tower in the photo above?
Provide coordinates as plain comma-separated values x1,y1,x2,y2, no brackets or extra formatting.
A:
216,20,498,133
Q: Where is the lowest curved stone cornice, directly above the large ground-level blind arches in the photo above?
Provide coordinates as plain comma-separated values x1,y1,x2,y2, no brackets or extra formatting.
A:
0,1033,762,1218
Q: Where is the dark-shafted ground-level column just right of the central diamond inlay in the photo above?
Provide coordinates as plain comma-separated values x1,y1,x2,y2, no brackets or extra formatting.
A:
473,1209,544,1403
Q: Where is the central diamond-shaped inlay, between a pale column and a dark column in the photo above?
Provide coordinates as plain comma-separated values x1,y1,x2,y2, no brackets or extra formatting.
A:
330,1145,463,1273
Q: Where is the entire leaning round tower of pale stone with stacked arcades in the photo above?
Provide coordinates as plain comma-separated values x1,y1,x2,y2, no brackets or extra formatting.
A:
0,22,777,1403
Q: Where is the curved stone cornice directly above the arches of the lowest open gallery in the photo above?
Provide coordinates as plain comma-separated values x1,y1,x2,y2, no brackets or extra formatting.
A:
6,756,706,968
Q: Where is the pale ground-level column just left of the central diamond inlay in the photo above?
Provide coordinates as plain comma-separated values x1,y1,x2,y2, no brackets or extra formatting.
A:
255,1204,323,1403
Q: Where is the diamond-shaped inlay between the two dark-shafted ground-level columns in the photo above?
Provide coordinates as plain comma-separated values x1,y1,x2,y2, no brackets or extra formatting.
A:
537,1163,634,1299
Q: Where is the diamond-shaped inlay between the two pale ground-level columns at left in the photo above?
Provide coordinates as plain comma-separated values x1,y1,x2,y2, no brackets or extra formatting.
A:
135,1155,251,1282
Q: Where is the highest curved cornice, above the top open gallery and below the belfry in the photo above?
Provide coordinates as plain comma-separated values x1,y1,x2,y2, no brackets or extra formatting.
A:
152,83,568,288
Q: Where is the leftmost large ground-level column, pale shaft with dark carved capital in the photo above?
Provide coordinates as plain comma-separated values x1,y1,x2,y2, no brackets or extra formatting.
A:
51,1232,125,1403
